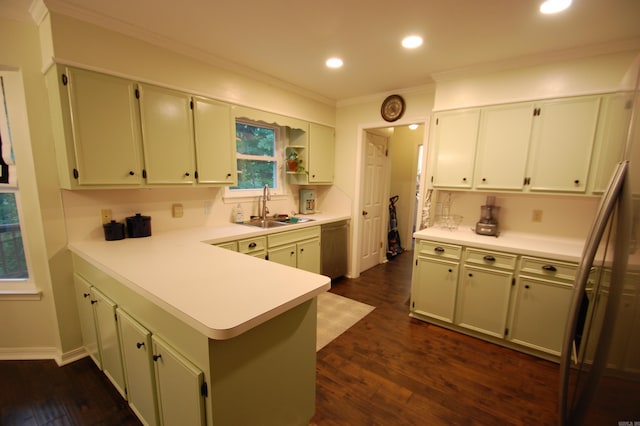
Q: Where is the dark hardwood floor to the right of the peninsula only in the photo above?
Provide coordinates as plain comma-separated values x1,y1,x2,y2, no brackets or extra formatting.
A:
313,252,558,426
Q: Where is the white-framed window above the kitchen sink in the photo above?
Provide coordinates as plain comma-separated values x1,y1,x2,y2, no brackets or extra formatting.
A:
227,119,284,197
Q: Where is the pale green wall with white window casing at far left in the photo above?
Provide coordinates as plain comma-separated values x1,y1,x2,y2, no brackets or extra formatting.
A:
0,18,70,358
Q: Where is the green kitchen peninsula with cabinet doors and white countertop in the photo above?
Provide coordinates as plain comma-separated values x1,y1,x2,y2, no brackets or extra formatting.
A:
69,220,330,425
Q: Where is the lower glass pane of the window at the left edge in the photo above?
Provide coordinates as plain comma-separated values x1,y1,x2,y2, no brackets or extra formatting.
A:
0,193,29,280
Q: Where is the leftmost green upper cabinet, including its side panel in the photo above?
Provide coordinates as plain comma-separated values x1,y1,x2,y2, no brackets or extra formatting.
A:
47,66,143,189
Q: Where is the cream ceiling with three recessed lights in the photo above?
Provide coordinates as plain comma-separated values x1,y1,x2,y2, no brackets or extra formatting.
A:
0,0,640,102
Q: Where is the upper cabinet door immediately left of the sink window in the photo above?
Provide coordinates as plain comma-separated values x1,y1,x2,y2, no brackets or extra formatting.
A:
193,97,238,185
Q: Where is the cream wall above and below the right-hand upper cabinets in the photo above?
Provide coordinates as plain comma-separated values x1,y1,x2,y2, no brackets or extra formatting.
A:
425,51,640,238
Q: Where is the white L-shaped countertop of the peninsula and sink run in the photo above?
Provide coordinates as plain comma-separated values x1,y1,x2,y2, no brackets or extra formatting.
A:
69,215,349,340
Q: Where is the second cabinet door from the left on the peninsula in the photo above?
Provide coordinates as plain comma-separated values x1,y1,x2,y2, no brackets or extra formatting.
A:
92,288,127,399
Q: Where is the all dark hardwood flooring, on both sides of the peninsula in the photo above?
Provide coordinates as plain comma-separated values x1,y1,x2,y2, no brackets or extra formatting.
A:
0,252,558,426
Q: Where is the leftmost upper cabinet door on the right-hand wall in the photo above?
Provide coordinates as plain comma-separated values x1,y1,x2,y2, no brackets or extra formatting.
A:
431,110,480,188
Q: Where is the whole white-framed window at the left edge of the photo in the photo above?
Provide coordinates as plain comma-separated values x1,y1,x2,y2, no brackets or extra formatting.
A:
0,70,29,290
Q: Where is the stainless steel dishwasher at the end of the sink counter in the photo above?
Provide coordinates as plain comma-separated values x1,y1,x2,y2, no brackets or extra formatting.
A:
320,220,349,279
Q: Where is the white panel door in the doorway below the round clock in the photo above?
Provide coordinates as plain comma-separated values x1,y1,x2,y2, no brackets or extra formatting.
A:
360,134,388,272
